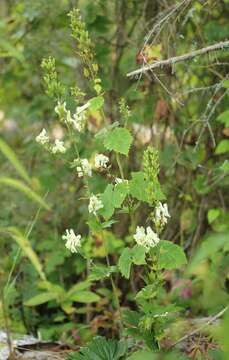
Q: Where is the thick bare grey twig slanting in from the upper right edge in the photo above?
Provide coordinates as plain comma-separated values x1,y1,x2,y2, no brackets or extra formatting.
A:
127,40,229,77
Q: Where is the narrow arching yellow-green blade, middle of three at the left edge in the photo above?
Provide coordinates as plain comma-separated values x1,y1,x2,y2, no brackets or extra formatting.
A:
0,177,50,210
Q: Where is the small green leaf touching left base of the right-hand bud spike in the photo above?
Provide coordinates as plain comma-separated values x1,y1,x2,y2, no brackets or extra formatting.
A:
129,171,148,202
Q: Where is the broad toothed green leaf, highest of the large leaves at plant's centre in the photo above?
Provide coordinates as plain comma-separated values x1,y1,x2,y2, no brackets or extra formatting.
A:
104,127,133,156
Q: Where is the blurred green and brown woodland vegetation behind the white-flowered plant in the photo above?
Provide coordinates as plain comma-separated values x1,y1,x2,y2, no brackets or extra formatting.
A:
0,0,229,359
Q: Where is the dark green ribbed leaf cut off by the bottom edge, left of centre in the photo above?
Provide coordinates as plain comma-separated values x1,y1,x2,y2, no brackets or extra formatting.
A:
69,336,127,360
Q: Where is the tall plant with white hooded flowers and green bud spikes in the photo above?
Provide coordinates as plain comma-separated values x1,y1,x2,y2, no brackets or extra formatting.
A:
31,10,186,354
